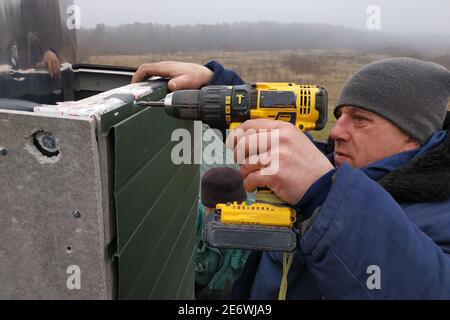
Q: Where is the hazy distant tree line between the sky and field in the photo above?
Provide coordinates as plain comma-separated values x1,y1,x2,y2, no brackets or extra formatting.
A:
77,21,450,57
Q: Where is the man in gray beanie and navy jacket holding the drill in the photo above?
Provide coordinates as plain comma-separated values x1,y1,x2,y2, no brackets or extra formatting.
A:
134,58,450,299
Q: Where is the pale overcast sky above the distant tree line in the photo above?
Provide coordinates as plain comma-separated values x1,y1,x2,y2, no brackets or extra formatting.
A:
75,0,450,34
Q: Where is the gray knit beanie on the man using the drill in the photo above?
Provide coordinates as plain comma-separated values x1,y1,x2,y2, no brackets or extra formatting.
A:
334,58,450,143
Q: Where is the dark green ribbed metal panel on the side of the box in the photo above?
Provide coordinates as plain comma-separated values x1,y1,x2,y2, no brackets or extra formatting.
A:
113,105,199,299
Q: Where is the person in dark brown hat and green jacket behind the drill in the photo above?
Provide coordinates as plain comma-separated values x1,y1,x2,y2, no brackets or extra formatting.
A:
195,167,250,300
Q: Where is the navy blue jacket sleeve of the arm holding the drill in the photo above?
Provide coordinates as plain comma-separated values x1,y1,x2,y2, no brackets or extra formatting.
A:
300,164,450,299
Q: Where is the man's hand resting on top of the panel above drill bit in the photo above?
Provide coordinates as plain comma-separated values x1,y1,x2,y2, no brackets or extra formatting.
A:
132,61,214,91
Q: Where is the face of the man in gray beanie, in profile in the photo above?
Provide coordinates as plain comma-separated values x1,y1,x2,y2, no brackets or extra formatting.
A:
330,106,419,168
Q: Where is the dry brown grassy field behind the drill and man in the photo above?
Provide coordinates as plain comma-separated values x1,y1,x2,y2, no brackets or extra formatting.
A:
82,48,450,141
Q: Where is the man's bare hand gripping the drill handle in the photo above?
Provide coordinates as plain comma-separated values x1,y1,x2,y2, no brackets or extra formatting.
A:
227,119,334,204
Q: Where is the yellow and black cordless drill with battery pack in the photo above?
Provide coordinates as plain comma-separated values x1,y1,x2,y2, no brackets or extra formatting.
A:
137,83,328,252
